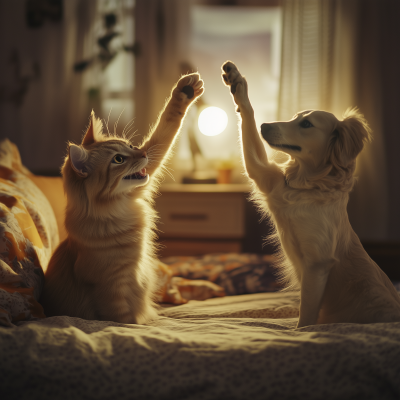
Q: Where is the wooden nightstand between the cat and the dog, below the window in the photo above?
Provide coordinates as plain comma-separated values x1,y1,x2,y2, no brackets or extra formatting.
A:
156,184,250,257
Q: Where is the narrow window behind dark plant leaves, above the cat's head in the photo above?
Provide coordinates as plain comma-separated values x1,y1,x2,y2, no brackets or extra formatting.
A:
85,0,135,134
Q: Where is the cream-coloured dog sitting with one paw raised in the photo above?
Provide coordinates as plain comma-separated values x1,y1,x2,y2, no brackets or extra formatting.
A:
222,61,400,327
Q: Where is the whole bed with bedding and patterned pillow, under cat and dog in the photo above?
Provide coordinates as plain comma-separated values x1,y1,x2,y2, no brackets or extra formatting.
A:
0,138,400,400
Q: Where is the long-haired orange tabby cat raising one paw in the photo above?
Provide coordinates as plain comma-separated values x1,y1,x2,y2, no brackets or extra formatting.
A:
41,73,204,323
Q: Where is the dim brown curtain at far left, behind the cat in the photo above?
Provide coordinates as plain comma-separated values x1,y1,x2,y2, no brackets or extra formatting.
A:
0,0,96,174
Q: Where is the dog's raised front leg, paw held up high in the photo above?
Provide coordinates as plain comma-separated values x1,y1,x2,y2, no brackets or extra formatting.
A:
222,61,284,193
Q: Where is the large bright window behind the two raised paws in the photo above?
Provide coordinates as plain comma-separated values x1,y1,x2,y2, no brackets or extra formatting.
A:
178,5,281,159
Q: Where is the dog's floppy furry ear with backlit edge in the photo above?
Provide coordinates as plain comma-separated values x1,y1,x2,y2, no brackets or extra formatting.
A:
328,108,372,169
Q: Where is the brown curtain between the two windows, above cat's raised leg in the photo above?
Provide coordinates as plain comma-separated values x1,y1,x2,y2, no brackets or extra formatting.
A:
134,0,191,140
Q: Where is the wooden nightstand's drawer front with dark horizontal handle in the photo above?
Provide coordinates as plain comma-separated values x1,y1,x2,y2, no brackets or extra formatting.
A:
156,193,245,238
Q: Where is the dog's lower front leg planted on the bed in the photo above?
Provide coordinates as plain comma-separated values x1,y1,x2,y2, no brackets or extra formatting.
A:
297,262,331,328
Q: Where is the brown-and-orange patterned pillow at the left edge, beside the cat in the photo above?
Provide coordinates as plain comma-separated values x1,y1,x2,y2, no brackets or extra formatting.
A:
0,139,59,326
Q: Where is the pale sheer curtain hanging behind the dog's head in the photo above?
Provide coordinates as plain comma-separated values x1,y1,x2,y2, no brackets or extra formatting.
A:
278,0,388,241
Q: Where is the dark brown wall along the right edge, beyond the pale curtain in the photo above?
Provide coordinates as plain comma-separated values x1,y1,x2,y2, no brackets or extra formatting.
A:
350,0,400,241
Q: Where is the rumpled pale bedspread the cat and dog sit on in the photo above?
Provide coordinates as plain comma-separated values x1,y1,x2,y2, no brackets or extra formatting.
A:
0,293,400,400
